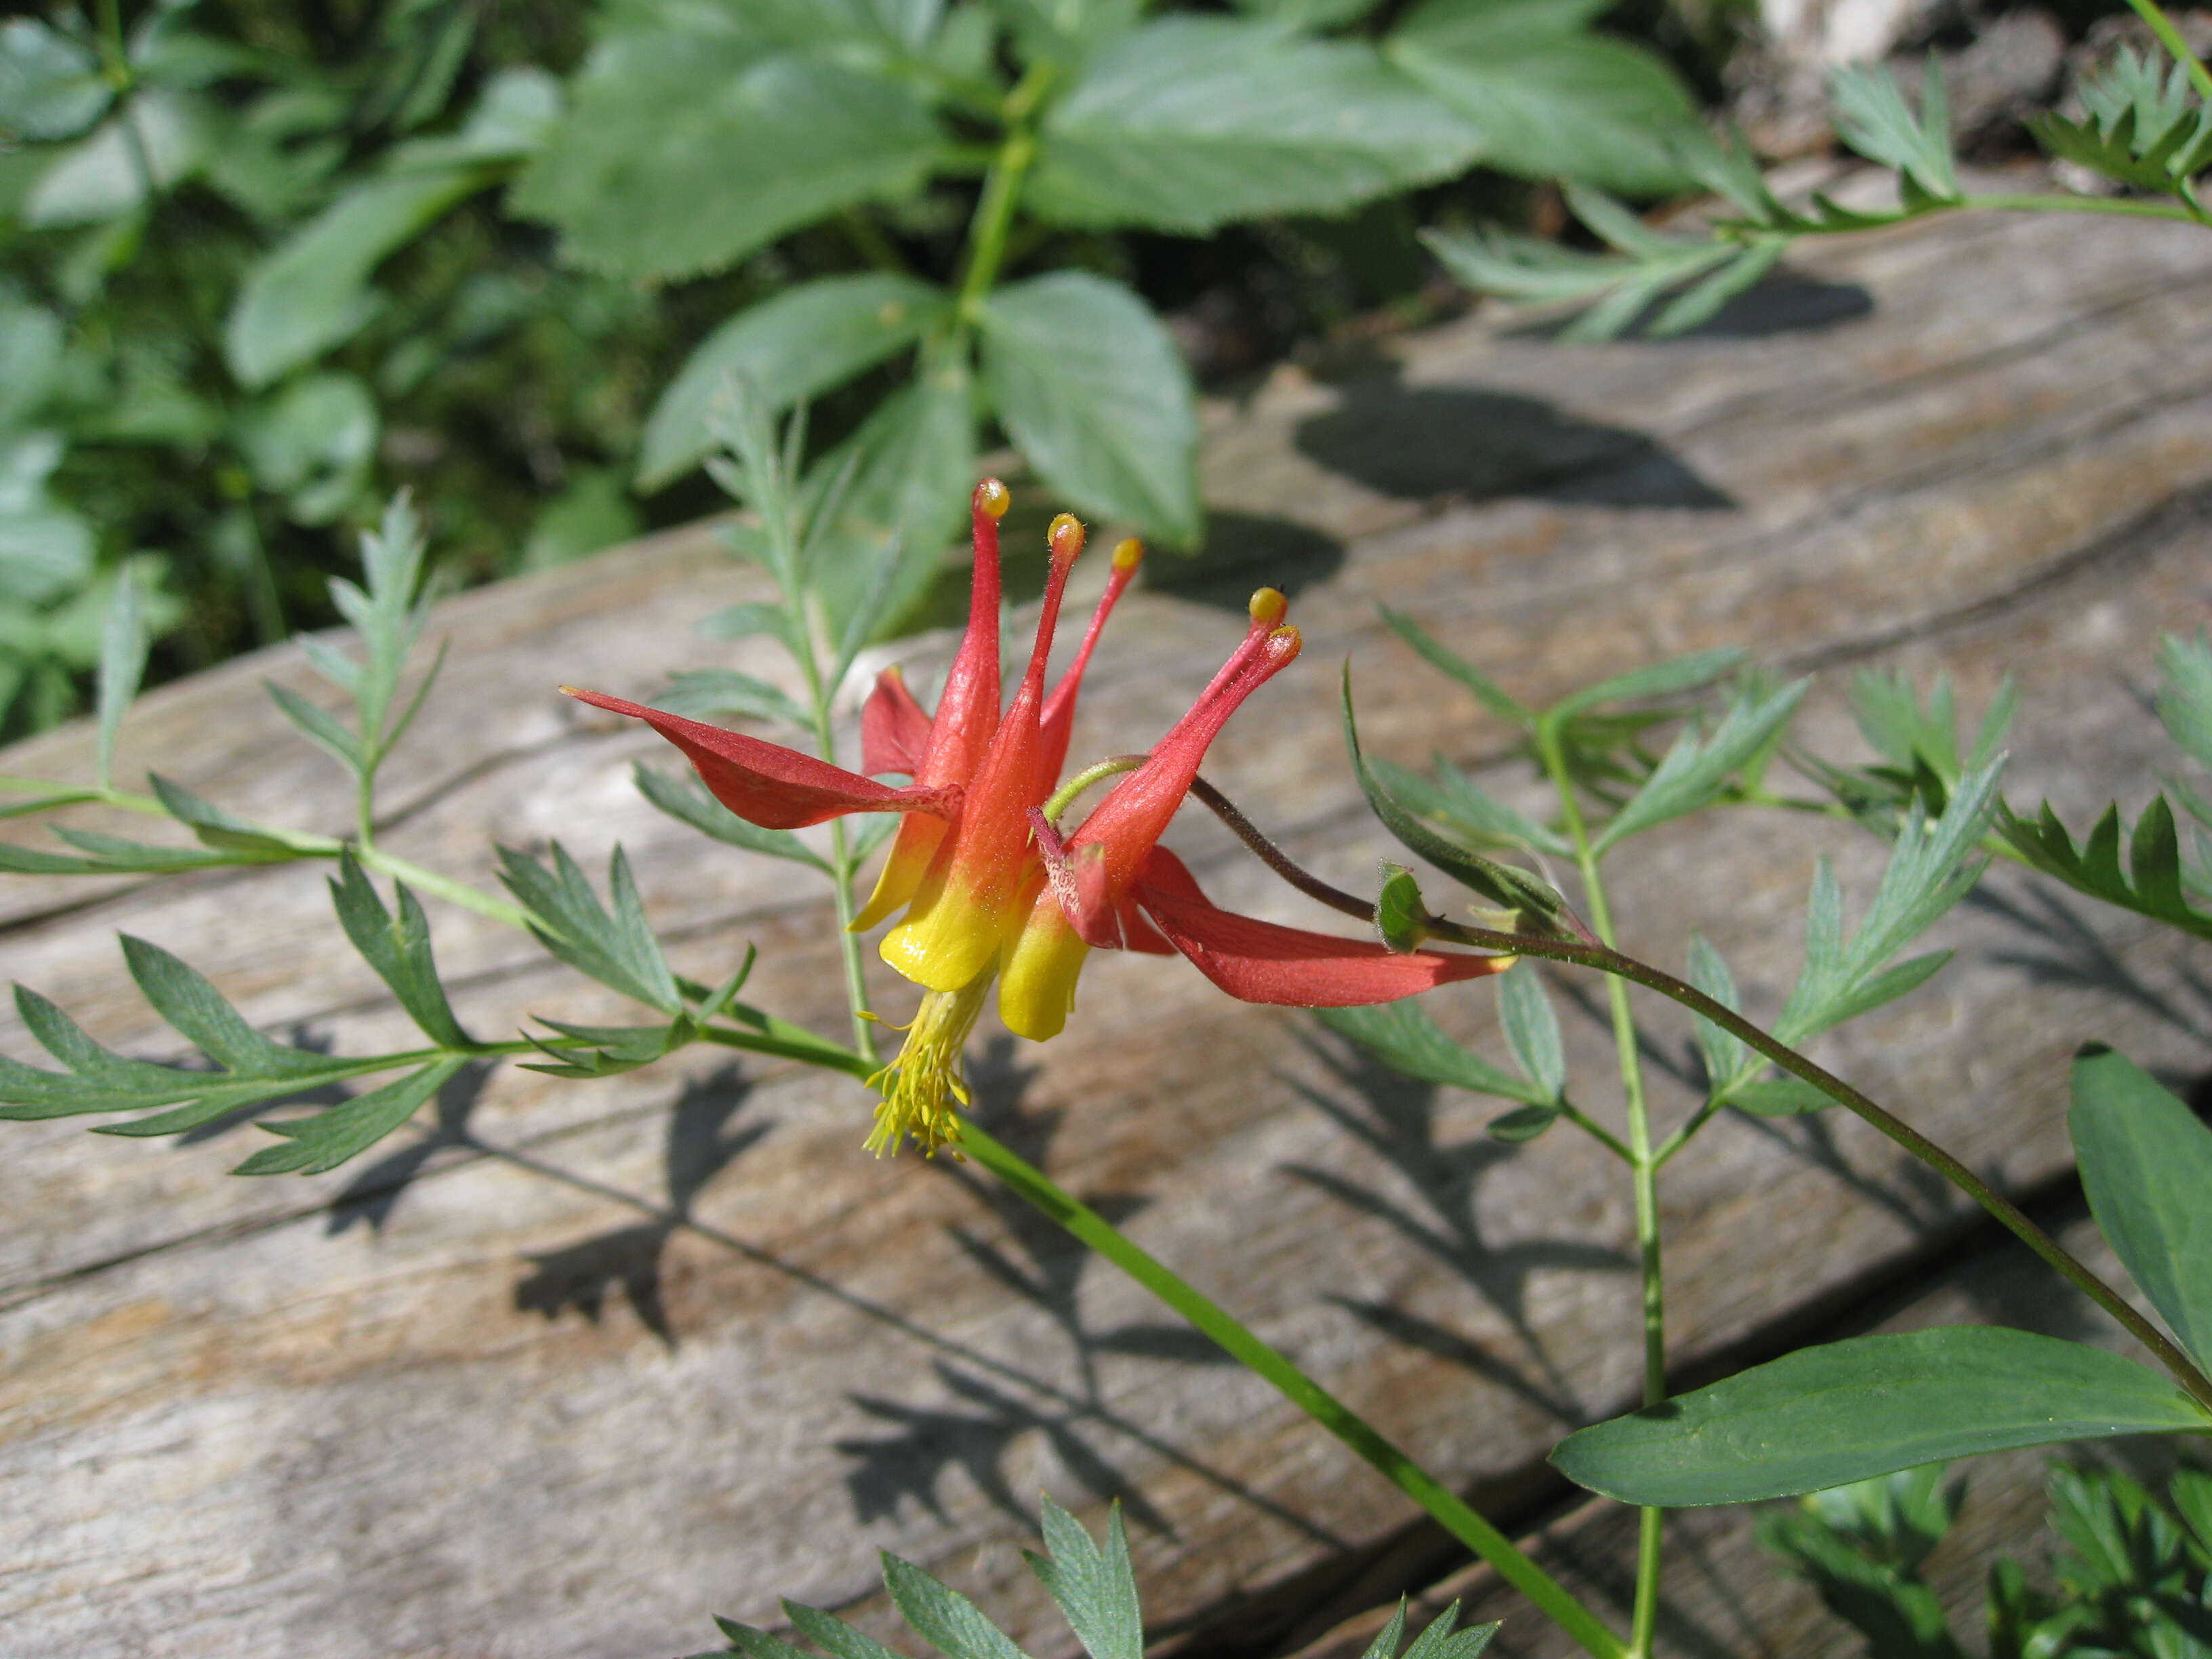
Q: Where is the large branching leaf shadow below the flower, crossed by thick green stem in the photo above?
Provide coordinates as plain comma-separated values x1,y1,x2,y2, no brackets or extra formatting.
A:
836,1036,1343,1549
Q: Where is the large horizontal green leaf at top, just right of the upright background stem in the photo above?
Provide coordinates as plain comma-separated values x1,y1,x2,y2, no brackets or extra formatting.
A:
1029,16,1477,234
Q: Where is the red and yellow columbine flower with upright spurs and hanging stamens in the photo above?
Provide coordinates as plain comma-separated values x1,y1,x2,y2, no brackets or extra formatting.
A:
562,478,1513,1155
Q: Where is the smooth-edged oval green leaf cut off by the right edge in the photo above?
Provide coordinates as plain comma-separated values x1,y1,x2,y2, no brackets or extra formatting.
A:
2066,1050,2212,1365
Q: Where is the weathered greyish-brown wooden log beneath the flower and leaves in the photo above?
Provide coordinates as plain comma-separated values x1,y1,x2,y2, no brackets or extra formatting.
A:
0,198,2212,1654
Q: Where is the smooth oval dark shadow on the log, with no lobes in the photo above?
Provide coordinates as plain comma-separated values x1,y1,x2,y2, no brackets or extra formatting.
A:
1296,363,1736,511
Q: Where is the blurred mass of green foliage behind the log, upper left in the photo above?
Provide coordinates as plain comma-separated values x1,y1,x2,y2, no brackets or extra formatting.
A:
0,0,1717,737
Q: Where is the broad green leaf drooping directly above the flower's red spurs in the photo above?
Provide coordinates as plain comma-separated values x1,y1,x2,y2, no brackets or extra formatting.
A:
982,270,1204,548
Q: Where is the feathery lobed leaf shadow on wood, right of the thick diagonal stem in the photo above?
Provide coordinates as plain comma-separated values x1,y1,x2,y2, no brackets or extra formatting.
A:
1283,1036,1635,1427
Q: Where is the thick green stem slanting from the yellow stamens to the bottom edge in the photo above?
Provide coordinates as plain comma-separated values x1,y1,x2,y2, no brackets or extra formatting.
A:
960,1124,1628,1659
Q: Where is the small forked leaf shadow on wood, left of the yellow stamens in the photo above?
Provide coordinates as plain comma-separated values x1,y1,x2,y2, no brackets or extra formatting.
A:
516,1066,774,1349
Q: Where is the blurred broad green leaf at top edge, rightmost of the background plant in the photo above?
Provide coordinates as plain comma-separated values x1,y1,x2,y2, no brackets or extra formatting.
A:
1382,0,1696,194
